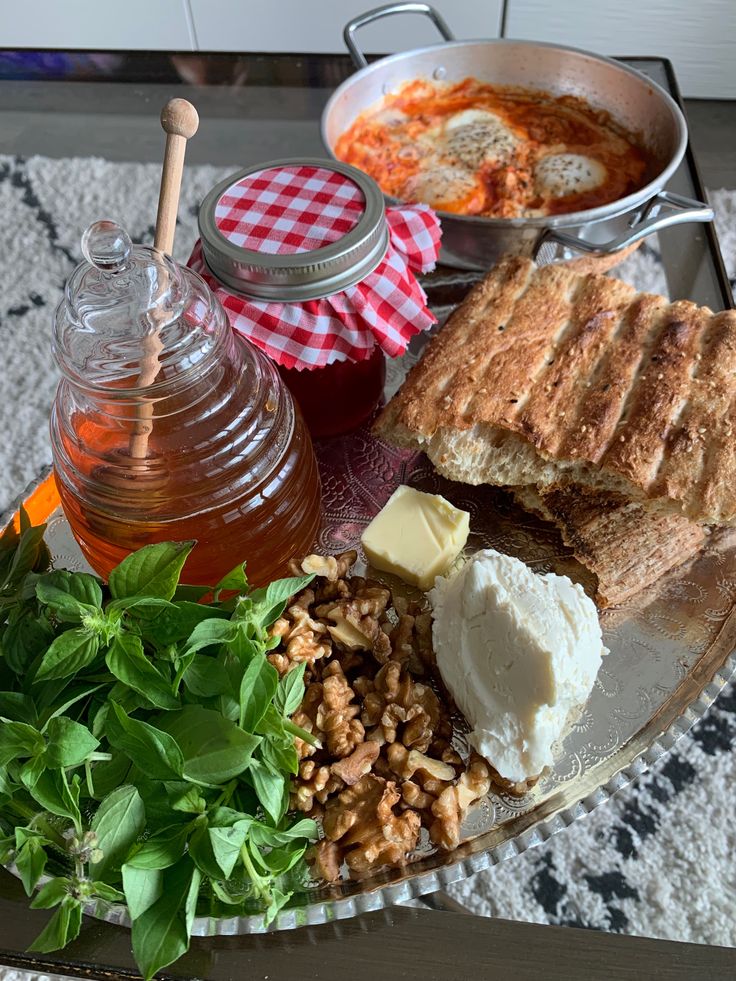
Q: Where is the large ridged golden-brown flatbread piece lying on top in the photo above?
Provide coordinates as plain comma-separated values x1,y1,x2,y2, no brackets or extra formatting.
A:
375,257,736,524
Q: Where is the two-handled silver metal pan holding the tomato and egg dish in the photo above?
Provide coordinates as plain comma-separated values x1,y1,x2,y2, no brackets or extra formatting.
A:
321,3,713,269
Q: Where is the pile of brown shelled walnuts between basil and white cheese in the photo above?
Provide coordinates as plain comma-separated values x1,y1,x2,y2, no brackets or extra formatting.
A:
269,551,490,882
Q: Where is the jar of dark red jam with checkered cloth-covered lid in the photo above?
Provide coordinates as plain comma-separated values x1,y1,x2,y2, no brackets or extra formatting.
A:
189,159,439,437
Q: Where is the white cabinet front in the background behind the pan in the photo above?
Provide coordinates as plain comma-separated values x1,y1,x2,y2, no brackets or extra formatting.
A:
0,0,736,99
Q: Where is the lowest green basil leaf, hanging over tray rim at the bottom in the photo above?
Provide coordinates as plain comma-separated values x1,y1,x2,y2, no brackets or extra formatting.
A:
132,856,199,981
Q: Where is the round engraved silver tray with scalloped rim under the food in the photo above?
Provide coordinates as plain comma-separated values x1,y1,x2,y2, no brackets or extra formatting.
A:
7,328,736,936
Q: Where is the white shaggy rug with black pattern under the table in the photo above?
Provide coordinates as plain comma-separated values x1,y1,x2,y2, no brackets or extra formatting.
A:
0,156,736,946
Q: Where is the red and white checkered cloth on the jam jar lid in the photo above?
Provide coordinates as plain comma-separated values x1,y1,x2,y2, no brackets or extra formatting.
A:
188,165,440,368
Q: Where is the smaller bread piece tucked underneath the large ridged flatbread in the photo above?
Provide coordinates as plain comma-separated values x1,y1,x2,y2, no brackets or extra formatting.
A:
514,484,705,607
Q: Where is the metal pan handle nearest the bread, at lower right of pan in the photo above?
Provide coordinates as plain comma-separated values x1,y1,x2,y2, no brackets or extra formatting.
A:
533,191,713,265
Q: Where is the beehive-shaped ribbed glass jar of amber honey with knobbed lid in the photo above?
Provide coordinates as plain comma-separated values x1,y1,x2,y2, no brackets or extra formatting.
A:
51,221,320,585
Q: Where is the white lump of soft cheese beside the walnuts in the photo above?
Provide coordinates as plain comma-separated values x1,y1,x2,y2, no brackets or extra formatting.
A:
430,549,607,782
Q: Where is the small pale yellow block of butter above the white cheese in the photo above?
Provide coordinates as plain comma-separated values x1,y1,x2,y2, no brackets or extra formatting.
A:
361,484,470,590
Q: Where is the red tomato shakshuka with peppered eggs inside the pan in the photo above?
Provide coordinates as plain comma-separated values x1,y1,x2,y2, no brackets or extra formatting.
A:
335,78,650,218
